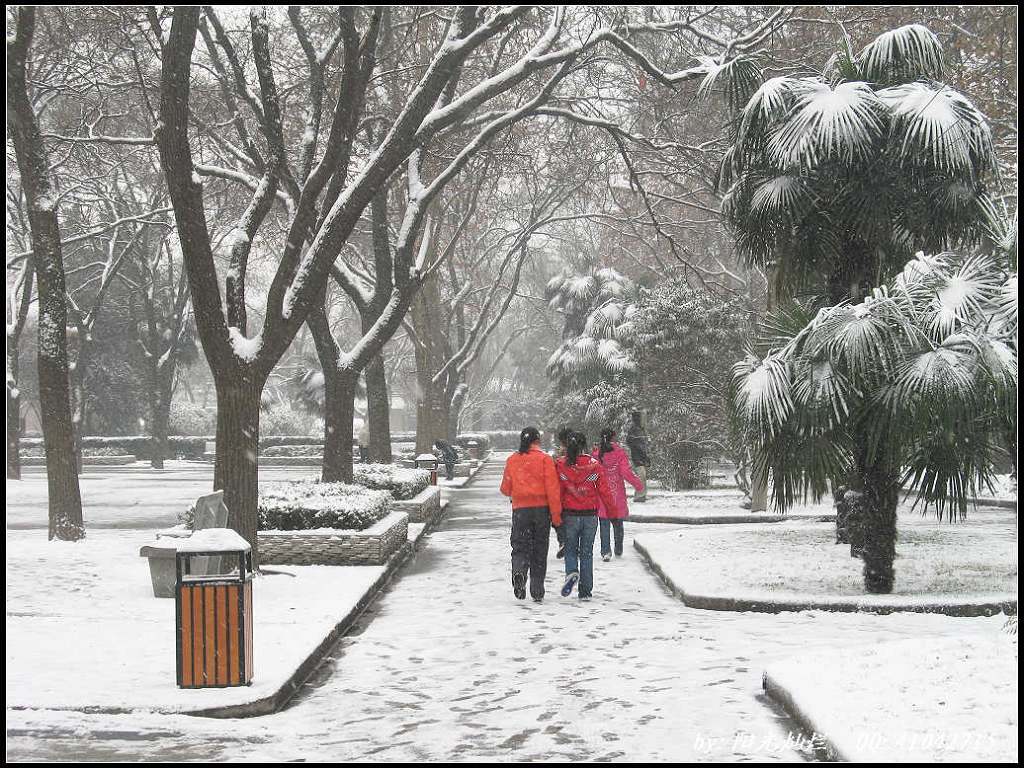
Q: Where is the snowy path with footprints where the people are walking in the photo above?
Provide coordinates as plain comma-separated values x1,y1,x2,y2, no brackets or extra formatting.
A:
7,461,992,761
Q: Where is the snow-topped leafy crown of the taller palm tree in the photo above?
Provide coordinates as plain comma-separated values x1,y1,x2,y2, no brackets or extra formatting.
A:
716,25,995,303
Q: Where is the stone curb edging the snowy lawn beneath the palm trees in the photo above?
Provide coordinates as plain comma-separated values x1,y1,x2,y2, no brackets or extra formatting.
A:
633,539,1017,617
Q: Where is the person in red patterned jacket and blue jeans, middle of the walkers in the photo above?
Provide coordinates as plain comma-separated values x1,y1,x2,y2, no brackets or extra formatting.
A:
555,432,615,600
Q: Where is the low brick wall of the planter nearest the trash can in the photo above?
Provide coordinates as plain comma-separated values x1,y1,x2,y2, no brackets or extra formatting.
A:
257,512,409,565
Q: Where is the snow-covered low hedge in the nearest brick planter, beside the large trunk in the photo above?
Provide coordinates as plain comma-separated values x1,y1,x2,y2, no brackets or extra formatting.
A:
258,480,391,530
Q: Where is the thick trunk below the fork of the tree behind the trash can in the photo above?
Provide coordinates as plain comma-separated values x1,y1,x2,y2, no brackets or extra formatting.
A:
213,378,263,566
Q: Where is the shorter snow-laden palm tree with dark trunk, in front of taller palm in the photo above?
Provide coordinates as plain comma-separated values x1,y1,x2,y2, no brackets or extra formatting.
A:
733,253,1017,593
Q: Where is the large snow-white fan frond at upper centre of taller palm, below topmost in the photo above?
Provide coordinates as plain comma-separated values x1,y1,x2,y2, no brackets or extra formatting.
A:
769,82,885,168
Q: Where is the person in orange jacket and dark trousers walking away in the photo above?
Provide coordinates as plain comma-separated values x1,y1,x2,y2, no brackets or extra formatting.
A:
501,427,562,602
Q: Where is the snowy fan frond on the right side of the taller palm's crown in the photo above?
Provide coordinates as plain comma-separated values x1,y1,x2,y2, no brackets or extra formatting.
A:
878,82,994,177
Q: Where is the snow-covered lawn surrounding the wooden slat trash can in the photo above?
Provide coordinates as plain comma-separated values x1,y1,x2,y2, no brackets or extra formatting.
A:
6,529,384,712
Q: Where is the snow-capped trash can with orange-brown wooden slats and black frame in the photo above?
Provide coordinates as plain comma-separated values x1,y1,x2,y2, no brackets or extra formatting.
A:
175,528,253,688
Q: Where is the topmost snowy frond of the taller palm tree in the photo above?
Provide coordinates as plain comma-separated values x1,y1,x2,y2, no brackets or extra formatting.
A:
858,24,944,84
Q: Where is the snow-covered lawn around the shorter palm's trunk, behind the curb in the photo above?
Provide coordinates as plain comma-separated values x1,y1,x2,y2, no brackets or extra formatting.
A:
634,507,1017,599
